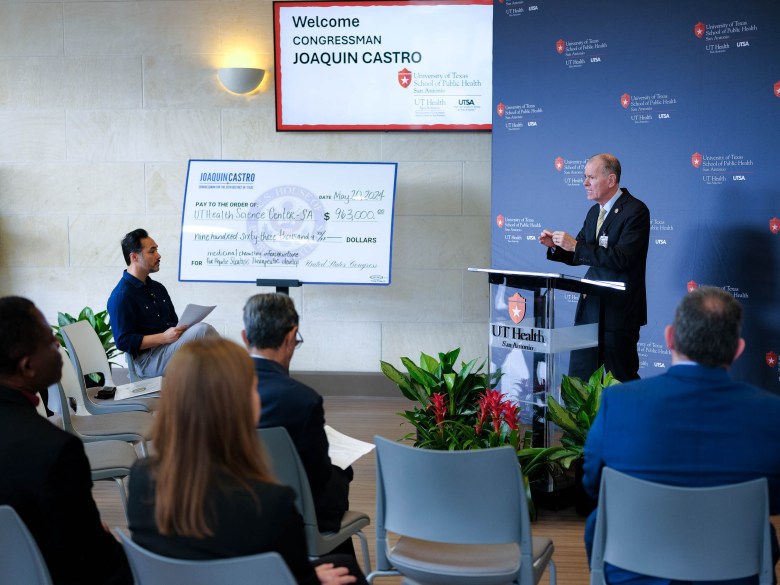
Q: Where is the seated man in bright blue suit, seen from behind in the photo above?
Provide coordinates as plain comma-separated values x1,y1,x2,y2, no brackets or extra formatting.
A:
583,287,780,584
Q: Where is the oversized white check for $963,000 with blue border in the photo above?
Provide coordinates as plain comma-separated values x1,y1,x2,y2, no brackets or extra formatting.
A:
179,160,397,285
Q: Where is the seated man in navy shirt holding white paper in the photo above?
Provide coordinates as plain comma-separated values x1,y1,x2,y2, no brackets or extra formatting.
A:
108,229,218,378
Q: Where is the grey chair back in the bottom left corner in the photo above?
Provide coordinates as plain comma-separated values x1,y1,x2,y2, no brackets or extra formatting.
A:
0,506,52,585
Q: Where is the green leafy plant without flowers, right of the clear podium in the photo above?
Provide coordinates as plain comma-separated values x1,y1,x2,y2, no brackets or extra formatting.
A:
547,365,620,515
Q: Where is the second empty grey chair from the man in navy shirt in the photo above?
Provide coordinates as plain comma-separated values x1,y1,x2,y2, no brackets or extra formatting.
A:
49,347,152,456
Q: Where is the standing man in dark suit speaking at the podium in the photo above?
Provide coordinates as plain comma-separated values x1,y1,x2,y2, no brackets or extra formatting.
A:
539,154,650,382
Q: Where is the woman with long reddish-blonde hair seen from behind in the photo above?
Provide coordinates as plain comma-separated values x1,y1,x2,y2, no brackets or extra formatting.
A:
127,338,365,585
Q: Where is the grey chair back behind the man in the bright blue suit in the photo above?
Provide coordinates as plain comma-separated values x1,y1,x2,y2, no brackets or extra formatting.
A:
590,467,774,585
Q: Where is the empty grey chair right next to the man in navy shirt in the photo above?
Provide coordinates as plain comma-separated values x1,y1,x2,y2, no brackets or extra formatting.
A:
60,321,159,414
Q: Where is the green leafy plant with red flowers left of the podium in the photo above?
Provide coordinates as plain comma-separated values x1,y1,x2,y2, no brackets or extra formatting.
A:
380,348,562,518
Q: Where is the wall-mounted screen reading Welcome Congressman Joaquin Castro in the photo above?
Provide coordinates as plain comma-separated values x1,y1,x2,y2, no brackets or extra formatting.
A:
274,0,493,131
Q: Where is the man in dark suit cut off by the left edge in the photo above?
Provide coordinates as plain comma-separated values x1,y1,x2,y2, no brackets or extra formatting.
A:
0,297,132,585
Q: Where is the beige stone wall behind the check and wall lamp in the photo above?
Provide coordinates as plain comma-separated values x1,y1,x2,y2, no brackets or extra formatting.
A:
0,0,490,372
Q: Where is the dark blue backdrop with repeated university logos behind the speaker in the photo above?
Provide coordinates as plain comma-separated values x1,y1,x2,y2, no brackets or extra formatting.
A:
492,0,780,392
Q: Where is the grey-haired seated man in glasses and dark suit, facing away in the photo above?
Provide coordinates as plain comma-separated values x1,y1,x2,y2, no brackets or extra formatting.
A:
241,293,354,540
